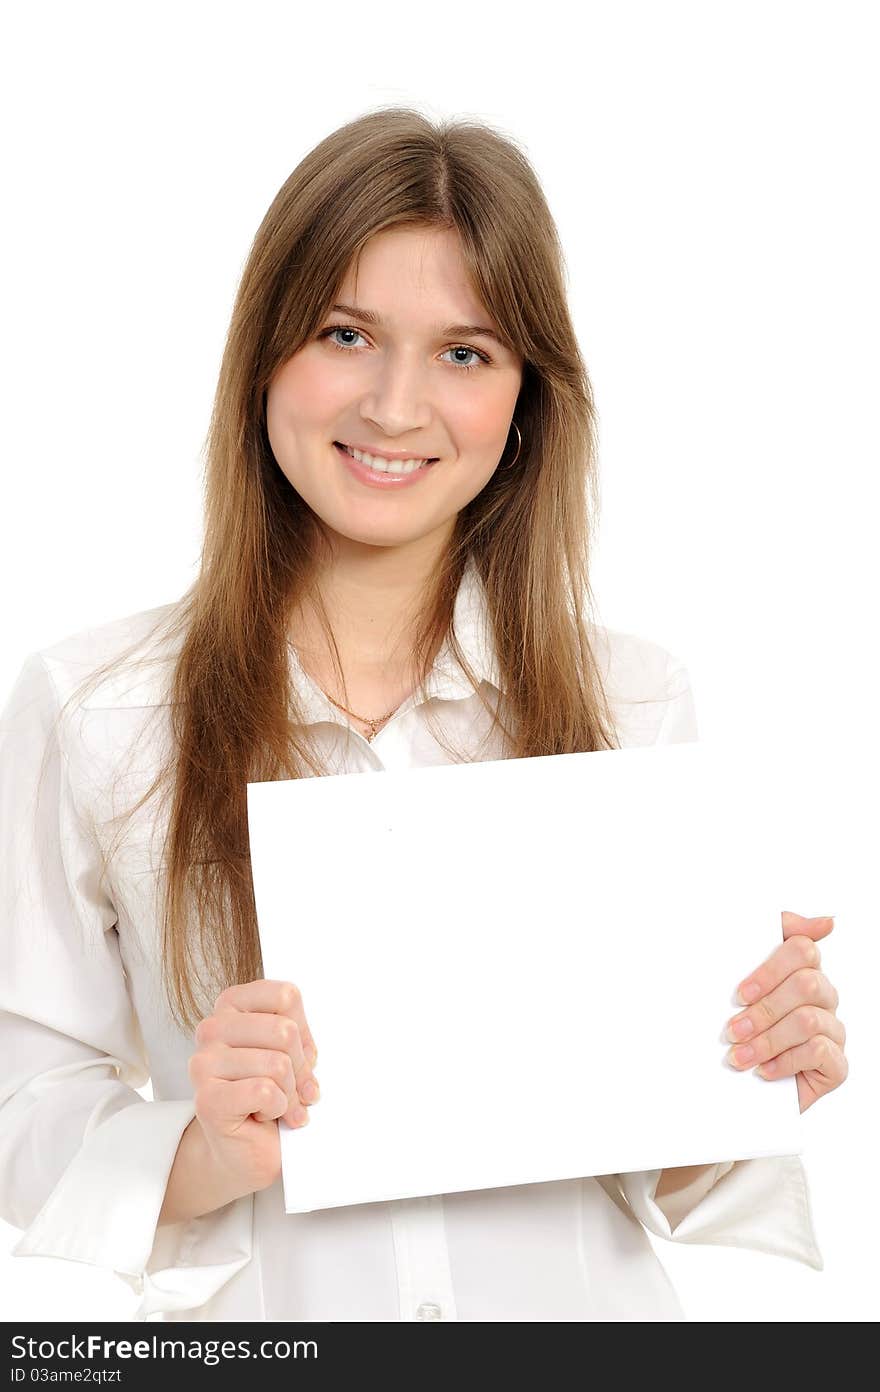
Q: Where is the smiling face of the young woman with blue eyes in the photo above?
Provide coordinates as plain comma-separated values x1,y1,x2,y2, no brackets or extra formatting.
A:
266,227,522,547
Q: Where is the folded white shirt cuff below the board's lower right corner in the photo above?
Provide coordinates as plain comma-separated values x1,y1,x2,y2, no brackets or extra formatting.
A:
618,1155,824,1271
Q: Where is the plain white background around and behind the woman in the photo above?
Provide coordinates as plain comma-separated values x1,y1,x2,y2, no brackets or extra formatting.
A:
0,0,880,1321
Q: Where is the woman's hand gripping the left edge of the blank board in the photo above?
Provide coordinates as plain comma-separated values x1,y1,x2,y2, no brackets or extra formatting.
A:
188,979,317,1193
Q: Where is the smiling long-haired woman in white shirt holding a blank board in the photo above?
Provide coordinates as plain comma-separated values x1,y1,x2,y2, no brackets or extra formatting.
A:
0,109,847,1321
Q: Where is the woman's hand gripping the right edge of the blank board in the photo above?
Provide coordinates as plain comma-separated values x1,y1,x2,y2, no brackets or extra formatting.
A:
727,910,849,1112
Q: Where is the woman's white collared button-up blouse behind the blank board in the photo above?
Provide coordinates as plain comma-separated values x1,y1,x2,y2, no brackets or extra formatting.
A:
0,567,823,1321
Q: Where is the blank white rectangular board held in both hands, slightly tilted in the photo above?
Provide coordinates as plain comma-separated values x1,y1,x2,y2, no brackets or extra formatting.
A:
248,742,802,1212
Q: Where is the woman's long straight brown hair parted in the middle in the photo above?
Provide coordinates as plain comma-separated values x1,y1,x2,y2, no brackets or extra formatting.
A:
53,107,618,1031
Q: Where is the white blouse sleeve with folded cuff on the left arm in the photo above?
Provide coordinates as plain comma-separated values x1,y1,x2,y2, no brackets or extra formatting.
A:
0,654,253,1320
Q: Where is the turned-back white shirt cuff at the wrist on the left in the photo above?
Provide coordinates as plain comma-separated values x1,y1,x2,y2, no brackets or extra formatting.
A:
13,1100,253,1320
